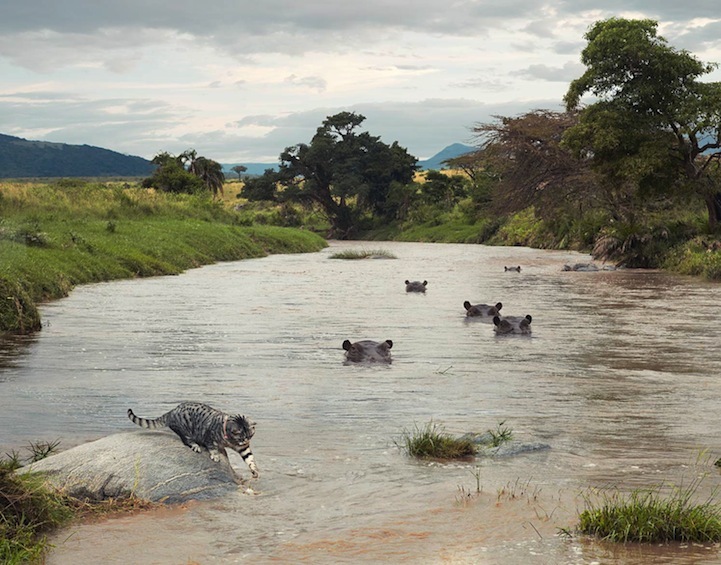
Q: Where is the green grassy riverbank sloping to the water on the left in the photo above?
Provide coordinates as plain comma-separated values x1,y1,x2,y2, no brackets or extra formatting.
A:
0,181,326,333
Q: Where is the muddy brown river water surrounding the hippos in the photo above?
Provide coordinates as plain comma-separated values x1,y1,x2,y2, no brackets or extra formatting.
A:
0,242,721,564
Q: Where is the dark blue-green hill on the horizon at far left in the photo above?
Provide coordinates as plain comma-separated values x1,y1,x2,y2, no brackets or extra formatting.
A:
0,134,155,178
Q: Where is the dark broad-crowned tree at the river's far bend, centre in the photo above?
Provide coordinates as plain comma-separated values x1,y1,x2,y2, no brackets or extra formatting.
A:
272,112,417,239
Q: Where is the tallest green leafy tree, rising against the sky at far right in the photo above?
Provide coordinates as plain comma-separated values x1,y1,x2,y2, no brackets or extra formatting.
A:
564,18,721,229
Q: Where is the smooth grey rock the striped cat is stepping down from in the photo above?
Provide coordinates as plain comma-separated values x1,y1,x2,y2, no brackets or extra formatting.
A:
18,431,248,503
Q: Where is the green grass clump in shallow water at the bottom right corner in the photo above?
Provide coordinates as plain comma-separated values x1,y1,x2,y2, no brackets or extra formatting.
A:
578,478,721,543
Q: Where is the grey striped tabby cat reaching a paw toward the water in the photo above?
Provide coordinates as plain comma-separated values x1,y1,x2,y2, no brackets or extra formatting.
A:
128,402,259,478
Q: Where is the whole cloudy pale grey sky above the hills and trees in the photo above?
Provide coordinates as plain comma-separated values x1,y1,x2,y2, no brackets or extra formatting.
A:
0,0,721,163
